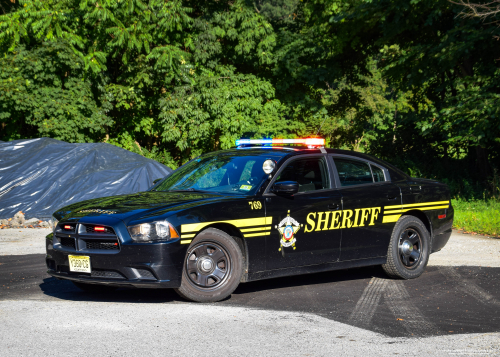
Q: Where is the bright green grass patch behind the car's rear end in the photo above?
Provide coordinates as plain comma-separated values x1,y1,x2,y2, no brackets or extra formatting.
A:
451,199,500,237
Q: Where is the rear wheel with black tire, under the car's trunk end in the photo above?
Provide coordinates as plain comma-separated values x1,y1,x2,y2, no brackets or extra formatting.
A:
382,216,431,279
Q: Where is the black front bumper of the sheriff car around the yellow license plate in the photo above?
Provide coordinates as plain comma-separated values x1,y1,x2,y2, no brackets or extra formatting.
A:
46,217,187,288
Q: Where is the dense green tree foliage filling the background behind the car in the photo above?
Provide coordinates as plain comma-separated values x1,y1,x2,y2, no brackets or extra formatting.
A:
0,0,500,197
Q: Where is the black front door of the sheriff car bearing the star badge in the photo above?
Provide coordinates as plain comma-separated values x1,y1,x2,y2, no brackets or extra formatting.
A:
265,155,342,270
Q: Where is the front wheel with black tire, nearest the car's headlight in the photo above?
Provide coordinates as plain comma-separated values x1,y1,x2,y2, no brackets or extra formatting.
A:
175,228,243,302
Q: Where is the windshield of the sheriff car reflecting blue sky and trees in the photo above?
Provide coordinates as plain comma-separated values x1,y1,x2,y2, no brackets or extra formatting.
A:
152,152,278,195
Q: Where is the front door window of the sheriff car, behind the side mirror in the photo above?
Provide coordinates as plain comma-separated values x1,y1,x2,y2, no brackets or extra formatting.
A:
276,157,330,192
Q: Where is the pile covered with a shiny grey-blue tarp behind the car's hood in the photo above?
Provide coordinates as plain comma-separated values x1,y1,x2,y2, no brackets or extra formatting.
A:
0,138,172,218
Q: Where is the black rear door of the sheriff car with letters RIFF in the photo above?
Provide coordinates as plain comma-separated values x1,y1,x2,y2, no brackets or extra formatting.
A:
332,155,401,261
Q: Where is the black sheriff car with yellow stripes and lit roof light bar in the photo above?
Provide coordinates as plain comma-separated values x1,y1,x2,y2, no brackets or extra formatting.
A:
46,138,453,302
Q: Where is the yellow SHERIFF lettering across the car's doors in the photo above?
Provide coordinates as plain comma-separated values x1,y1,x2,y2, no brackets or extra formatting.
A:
304,207,382,233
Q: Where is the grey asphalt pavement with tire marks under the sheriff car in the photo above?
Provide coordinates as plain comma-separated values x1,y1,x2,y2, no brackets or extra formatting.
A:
0,229,500,356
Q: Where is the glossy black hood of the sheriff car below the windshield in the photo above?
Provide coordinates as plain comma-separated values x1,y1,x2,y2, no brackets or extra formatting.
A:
54,191,224,221
